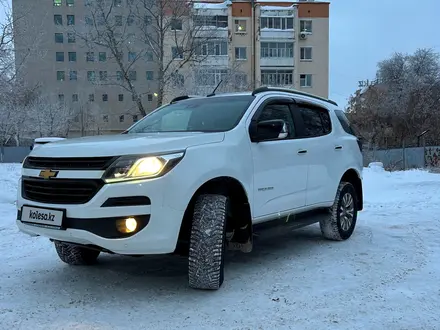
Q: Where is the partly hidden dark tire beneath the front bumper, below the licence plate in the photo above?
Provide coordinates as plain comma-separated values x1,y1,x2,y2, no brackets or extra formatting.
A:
54,241,100,265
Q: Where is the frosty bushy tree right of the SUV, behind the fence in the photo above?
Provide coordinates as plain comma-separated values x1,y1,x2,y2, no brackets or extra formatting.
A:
348,49,440,147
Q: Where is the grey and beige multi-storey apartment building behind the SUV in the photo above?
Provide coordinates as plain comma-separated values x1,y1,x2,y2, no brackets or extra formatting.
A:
12,0,329,136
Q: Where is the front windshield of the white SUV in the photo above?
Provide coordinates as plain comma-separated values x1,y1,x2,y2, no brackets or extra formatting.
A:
127,95,254,134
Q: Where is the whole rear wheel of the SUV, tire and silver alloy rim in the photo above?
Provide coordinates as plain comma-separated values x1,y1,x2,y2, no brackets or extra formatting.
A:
319,182,358,241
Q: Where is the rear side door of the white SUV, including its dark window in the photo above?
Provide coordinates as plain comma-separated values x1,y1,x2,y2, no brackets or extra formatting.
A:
295,103,342,206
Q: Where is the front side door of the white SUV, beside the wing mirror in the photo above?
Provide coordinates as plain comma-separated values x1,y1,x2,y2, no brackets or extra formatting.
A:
251,97,308,219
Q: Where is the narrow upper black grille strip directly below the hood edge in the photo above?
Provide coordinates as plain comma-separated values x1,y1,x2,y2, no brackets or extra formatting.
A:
23,157,116,170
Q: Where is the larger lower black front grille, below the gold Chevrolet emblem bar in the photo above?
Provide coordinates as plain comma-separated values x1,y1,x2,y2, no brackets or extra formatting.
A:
22,177,104,204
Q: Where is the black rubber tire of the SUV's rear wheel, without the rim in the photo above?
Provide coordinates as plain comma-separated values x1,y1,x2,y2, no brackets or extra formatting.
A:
319,182,358,241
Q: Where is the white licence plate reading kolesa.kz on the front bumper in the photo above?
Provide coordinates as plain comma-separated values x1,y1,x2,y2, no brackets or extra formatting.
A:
20,206,65,229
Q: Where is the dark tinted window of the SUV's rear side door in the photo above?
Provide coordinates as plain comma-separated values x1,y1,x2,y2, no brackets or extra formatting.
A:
298,106,331,137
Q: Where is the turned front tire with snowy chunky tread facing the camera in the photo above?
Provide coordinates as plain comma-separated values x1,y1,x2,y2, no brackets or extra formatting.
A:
188,195,229,290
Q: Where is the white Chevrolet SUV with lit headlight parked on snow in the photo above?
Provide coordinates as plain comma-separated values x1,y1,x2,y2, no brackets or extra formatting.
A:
17,87,363,289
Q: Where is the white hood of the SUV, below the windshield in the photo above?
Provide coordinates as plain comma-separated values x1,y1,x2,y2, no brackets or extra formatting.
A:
30,132,224,157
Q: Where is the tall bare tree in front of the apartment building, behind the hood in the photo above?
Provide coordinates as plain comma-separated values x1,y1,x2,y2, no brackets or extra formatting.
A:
77,0,227,115
